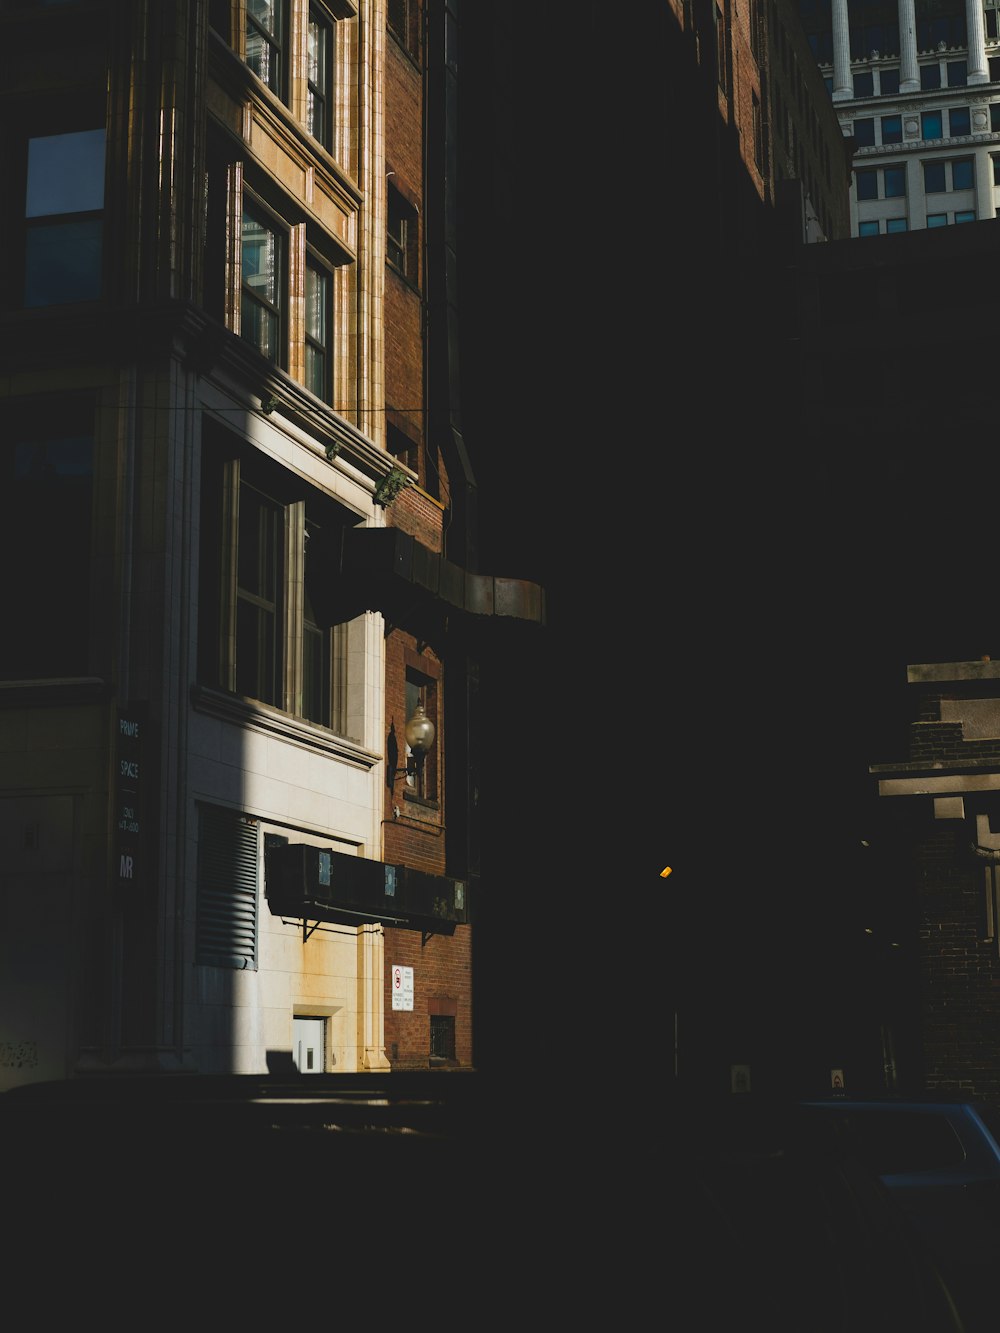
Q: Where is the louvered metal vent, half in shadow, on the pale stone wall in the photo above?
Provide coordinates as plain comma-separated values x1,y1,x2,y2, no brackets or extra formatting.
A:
195,805,257,969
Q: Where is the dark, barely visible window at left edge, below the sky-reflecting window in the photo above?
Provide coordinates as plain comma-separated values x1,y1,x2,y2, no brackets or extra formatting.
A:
0,396,95,680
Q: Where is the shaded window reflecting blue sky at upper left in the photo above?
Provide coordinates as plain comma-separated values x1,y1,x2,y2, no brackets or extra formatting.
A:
24,128,105,307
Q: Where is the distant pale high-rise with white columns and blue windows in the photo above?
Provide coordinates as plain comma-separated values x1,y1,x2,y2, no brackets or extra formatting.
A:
800,0,1000,236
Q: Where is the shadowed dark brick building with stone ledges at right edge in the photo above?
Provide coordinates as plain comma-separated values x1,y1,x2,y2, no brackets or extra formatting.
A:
871,659,1000,1101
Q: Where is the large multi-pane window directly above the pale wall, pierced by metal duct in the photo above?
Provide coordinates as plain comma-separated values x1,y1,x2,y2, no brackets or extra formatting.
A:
199,423,353,734
